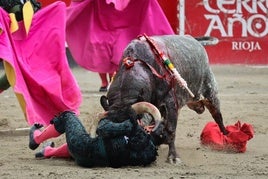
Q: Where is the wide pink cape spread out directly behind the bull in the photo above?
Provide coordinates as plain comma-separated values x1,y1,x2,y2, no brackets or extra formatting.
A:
66,0,174,73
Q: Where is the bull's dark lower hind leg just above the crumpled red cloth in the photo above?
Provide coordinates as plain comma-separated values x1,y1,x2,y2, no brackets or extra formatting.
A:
202,97,228,135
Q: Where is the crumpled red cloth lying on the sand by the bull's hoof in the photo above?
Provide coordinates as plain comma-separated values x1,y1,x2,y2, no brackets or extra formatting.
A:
200,121,254,152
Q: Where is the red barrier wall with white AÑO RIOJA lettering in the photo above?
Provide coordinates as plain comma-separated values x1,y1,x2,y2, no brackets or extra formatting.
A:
179,0,268,64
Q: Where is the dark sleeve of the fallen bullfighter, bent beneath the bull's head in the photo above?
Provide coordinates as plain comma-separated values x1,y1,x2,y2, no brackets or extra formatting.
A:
97,119,133,138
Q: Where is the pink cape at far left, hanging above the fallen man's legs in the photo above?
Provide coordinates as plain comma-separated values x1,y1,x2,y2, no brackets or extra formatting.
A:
0,2,81,125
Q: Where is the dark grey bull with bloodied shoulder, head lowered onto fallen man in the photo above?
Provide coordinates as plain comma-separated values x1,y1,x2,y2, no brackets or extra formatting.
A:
101,35,227,162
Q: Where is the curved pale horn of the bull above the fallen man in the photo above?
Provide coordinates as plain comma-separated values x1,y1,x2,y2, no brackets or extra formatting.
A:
131,101,162,131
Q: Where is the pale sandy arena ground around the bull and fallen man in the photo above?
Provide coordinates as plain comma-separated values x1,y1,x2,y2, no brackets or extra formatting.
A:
0,65,268,179
